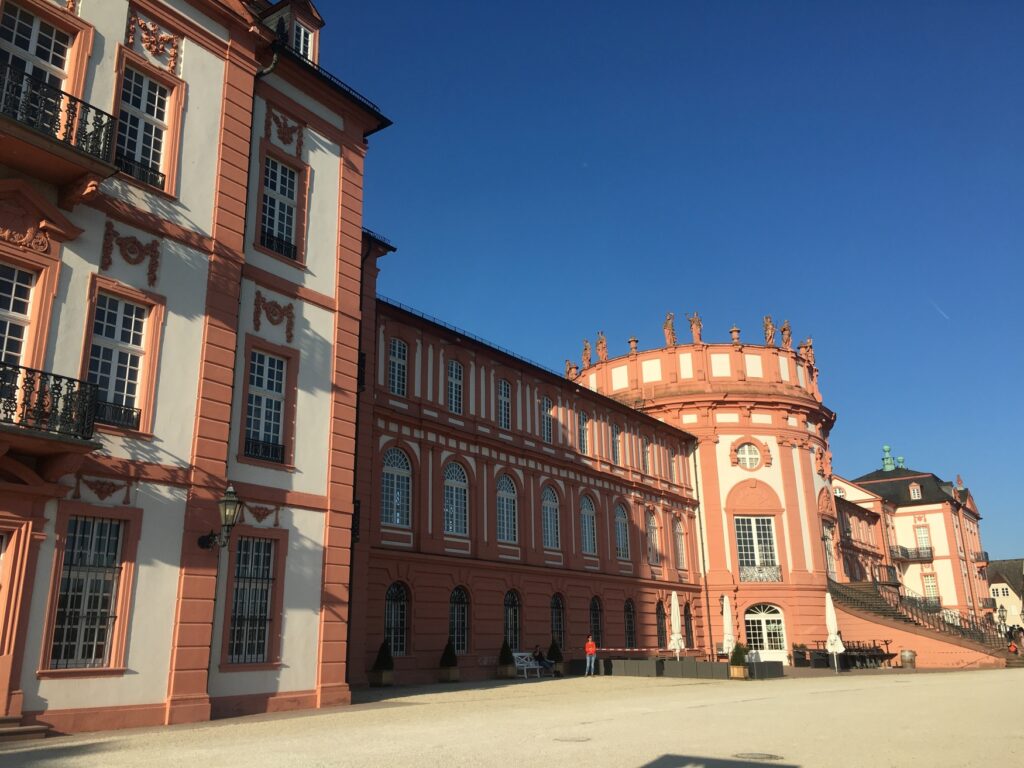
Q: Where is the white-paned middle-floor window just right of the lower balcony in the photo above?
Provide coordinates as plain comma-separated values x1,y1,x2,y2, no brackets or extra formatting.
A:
88,293,148,429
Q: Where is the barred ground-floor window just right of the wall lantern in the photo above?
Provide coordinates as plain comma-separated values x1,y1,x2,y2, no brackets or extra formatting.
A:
227,537,275,664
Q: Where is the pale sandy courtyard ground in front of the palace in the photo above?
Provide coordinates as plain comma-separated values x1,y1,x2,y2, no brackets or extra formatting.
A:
0,670,1024,768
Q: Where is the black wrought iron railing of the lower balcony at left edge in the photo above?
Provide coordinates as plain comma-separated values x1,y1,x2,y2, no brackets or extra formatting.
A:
0,362,97,440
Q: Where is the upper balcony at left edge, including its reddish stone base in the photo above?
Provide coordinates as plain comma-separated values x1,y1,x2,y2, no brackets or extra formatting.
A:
0,63,117,184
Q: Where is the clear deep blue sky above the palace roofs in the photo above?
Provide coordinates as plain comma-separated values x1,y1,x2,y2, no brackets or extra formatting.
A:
319,0,1024,558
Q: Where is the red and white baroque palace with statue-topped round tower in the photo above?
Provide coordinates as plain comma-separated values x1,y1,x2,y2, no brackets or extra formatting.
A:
0,0,1005,732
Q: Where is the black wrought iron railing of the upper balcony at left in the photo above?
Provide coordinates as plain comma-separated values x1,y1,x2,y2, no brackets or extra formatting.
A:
0,63,116,163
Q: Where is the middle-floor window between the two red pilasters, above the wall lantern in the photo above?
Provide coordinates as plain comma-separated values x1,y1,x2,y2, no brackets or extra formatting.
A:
245,349,288,464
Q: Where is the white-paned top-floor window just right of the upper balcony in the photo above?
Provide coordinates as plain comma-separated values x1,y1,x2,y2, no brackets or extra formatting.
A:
117,67,170,188
